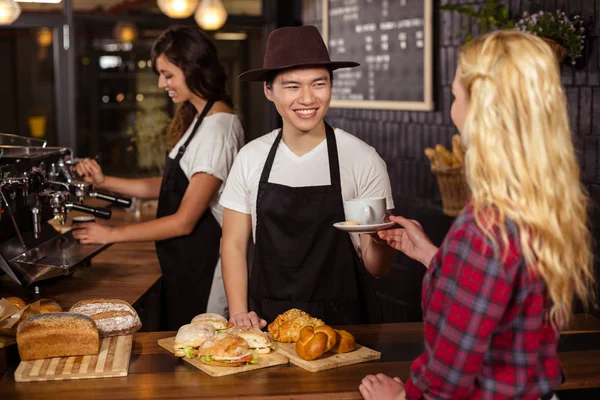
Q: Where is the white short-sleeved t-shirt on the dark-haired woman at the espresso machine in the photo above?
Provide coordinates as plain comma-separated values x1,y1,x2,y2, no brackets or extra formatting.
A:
169,113,244,226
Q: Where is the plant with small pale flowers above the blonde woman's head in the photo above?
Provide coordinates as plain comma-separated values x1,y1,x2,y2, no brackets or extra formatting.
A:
515,10,585,64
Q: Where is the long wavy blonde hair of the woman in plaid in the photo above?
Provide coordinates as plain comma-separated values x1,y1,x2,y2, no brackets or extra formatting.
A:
458,31,595,326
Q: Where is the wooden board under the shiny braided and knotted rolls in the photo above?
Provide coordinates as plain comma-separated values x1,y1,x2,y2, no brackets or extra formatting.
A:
276,342,381,372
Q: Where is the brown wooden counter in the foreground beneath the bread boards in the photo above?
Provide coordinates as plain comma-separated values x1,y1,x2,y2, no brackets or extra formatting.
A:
0,318,600,400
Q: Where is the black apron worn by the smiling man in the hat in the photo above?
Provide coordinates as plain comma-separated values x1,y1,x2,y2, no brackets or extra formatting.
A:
248,123,382,325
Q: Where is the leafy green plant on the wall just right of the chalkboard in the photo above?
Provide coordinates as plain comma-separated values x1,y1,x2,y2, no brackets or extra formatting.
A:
440,0,515,42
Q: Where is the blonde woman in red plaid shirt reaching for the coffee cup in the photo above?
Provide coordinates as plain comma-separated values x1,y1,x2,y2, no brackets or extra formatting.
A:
359,31,593,400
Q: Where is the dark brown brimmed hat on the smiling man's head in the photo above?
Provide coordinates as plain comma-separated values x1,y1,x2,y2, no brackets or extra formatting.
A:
238,25,360,81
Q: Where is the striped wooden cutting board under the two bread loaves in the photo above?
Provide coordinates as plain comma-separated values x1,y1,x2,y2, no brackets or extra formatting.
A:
15,335,133,382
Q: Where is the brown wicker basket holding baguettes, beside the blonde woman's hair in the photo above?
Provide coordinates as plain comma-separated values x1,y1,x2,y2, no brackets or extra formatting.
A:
431,166,471,217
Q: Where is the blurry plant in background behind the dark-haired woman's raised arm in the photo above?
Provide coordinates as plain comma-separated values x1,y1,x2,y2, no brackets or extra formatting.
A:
127,109,171,173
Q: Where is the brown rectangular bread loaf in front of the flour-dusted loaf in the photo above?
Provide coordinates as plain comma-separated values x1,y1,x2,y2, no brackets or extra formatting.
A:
17,312,100,361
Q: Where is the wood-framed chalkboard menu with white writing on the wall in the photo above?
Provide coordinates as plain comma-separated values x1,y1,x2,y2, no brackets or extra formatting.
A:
322,0,433,110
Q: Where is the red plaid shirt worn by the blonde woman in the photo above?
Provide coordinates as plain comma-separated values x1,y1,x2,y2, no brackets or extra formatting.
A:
406,206,561,399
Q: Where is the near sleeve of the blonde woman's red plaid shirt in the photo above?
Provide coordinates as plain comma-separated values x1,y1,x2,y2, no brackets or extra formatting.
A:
406,214,514,399
